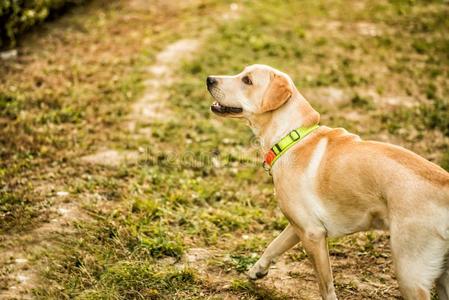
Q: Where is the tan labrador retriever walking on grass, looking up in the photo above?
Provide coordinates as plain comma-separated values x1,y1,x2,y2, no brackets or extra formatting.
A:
207,65,449,299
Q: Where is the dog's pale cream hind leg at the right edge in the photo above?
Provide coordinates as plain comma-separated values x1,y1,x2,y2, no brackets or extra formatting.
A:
390,222,448,300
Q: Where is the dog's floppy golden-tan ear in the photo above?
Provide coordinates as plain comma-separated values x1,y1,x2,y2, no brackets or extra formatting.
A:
261,74,292,112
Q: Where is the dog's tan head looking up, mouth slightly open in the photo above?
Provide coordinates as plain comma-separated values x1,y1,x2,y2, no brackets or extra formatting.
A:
207,65,294,118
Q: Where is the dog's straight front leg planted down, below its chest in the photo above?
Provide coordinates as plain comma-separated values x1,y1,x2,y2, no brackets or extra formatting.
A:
294,226,337,300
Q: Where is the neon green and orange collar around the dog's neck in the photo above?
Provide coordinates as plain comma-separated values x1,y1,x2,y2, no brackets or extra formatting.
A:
263,125,320,174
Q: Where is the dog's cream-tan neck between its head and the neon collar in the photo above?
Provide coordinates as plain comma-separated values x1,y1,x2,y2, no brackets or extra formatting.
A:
249,91,320,153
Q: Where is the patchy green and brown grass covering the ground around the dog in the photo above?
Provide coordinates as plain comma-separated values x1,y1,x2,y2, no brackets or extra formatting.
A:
0,0,449,299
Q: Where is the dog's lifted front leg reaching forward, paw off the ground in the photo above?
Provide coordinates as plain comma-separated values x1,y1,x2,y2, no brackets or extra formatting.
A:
248,224,299,280
